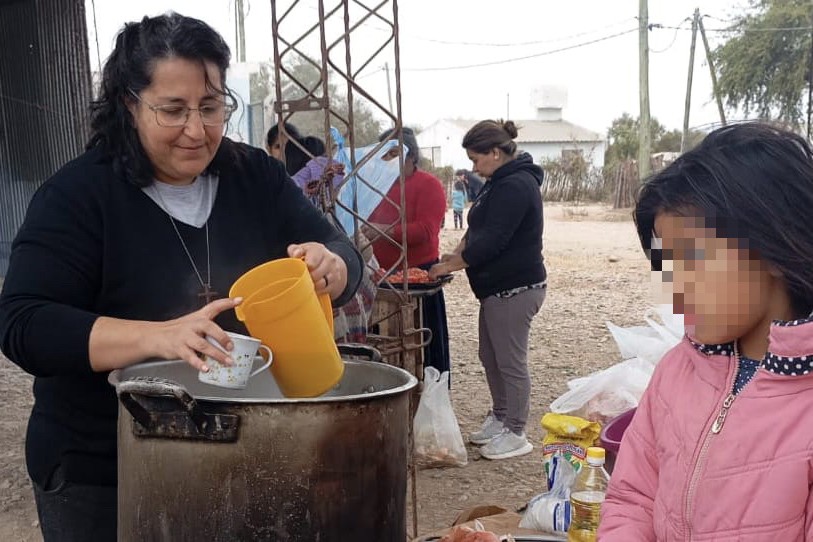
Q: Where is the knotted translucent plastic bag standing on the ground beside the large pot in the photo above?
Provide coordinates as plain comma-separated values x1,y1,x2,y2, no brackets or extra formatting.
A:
414,367,468,467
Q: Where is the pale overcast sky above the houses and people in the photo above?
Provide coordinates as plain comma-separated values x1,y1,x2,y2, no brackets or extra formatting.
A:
86,0,742,138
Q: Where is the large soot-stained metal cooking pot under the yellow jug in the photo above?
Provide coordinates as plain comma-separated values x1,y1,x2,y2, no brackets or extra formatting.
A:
110,349,417,542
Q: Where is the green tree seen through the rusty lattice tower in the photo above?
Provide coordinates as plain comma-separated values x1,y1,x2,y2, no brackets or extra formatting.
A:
266,59,382,147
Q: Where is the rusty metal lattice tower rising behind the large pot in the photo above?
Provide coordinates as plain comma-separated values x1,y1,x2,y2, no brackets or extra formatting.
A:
271,0,418,536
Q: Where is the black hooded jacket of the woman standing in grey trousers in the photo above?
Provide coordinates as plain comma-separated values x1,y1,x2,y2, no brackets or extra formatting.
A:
462,153,547,299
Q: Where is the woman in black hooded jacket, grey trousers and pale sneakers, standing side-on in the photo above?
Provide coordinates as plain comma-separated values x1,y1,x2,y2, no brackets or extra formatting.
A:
431,120,547,459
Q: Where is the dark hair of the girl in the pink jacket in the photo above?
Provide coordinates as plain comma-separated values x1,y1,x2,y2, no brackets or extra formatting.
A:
633,123,813,318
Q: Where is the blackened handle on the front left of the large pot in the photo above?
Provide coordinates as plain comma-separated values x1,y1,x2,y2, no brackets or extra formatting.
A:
116,376,240,442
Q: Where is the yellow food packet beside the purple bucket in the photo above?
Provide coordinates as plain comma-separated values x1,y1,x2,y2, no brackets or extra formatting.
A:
542,412,601,479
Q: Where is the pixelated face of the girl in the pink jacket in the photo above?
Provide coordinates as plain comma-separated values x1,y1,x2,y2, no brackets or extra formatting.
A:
653,213,792,359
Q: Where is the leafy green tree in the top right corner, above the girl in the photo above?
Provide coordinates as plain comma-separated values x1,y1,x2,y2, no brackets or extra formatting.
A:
713,0,811,127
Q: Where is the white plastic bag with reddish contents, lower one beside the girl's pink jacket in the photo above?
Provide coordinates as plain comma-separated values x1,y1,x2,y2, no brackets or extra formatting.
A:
550,358,655,425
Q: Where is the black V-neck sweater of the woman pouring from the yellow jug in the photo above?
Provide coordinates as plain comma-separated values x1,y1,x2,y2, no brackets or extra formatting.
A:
0,139,363,485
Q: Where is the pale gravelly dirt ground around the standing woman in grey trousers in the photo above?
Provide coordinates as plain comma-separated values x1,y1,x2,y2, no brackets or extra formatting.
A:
0,204,652,542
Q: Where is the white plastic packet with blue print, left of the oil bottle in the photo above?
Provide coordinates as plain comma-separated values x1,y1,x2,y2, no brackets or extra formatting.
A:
519,455,576,534
